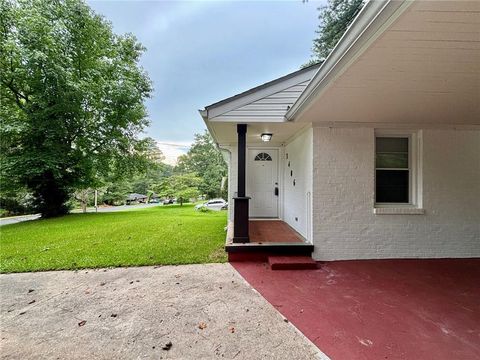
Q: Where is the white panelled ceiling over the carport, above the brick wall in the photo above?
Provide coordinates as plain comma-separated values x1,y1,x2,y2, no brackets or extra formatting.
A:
287,1,480,125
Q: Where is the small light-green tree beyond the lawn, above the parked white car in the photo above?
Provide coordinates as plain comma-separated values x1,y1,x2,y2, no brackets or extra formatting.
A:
156,173,202,205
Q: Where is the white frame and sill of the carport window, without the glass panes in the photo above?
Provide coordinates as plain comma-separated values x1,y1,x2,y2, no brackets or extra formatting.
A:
373,129,422,208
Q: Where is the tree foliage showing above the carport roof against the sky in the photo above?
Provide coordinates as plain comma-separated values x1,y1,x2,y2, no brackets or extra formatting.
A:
305,0,364,66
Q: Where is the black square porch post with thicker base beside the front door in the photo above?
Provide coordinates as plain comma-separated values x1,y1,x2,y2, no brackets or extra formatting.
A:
233,124,250,243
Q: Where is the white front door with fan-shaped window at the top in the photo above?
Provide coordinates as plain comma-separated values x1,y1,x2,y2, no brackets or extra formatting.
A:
247,149,278,218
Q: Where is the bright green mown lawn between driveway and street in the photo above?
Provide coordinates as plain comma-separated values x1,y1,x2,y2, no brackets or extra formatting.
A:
0,205,226,273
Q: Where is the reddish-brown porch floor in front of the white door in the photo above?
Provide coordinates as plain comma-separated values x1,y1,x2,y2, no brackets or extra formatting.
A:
249,220,305,244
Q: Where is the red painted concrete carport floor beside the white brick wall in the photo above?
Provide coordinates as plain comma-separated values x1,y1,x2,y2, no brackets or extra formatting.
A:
232,259,480,360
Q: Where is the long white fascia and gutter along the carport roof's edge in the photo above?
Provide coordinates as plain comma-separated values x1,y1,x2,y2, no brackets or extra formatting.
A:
285,0,415,121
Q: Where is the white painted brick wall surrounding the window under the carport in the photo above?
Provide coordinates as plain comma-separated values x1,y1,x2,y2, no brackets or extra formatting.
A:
312,127,480,260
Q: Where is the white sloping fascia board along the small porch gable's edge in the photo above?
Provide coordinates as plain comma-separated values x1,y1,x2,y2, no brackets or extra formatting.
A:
205,69,316,120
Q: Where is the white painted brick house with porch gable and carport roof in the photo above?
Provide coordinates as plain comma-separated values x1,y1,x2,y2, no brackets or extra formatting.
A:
201,1,480,260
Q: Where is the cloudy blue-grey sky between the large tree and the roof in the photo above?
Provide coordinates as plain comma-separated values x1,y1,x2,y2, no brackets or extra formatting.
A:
87,0,323,164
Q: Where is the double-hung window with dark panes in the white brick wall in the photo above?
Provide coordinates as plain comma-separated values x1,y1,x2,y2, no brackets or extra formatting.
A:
375,134,415,205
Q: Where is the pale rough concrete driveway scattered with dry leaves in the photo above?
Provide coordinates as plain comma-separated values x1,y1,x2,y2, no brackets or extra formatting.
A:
0,264,323,359
